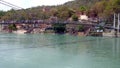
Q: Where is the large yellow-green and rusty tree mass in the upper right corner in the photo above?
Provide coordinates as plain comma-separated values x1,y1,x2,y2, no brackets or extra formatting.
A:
90,0,120,21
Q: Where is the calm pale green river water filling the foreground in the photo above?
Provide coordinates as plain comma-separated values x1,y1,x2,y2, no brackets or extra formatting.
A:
0,33,120,68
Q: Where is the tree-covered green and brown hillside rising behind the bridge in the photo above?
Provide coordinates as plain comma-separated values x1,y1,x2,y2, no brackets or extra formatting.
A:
0,0,120,21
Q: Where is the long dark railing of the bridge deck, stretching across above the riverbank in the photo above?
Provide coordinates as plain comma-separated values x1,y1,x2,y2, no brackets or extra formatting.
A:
0,20,96,25
